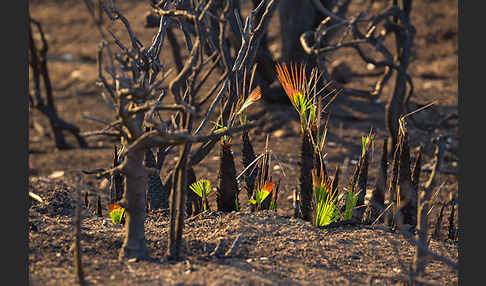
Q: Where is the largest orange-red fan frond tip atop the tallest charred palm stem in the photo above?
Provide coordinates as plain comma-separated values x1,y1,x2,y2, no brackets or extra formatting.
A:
276,63,306,104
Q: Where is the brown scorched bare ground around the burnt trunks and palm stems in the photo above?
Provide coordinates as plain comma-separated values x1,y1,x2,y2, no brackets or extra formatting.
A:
28,0,459,285
